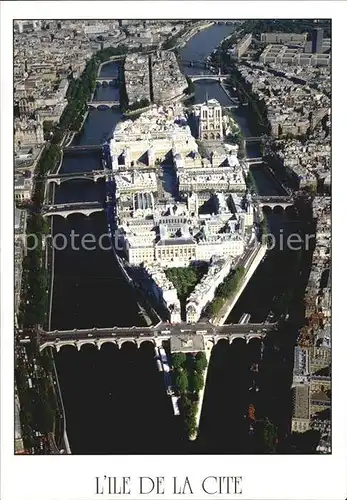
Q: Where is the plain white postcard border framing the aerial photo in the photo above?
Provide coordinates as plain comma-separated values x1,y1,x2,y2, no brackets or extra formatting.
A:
1,1,347,500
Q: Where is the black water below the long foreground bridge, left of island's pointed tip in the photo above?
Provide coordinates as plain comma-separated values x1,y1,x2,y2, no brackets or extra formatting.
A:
56,342,179,454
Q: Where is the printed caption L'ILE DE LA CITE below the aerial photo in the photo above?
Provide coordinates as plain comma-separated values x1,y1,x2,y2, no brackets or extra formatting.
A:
94,475,243,495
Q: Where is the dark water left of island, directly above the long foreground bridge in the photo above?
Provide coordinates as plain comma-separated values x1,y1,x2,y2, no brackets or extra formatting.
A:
52,212,144,329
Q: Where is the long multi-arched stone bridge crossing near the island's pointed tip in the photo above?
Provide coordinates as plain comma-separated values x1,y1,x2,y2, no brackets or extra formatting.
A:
34,322,277,352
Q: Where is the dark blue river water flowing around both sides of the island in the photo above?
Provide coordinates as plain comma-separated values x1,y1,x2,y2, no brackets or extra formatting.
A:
51,25,300,454
